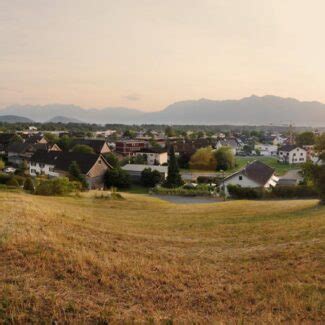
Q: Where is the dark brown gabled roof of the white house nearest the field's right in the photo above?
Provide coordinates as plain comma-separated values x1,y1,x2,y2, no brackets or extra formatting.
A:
225,160,274,186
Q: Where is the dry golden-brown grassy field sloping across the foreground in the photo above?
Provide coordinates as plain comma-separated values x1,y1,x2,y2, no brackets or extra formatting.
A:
0,192,325,324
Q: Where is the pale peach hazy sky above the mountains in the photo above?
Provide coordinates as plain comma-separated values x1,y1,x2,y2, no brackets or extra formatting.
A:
0,0,325,110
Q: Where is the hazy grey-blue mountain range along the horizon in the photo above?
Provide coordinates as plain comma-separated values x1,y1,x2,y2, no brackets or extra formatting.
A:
0,95,325,126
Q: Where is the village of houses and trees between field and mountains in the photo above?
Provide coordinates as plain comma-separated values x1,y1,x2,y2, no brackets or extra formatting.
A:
0,125,323,199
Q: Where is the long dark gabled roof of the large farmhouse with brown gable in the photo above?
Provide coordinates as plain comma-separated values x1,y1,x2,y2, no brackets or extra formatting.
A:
31,150,111,174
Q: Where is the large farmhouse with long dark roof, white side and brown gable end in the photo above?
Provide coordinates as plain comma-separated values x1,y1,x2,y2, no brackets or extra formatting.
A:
29,150,112,189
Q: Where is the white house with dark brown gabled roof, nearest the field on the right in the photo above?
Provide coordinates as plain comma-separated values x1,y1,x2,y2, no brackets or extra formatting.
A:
221,160,279,196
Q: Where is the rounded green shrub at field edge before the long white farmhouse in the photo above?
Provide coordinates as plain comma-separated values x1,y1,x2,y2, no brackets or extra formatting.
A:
35,177,76,196
